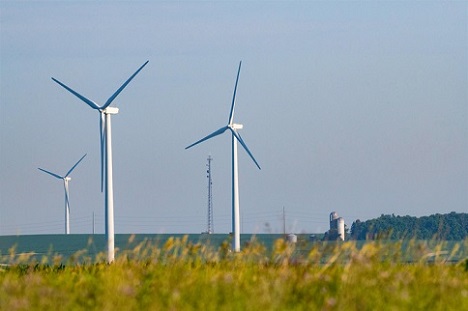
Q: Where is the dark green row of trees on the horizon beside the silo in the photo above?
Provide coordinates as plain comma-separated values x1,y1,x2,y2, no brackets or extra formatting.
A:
349,212,468,240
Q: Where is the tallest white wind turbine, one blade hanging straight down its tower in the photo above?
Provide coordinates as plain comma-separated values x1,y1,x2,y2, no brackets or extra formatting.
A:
52,61,149,263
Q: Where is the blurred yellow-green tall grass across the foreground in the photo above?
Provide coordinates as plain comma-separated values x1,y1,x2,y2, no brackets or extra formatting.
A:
0,238,468,311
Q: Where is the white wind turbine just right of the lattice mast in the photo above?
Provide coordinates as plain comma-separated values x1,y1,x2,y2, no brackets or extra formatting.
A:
185,61,260,252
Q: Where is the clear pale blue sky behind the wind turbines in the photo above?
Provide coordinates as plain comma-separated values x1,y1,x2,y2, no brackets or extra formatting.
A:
0,1,468,235
